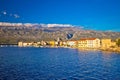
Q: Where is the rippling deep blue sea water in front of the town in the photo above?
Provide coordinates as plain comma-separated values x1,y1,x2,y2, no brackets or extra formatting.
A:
0,47,120,80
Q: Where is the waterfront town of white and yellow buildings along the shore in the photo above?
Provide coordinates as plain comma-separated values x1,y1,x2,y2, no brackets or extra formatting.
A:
18,38,120,52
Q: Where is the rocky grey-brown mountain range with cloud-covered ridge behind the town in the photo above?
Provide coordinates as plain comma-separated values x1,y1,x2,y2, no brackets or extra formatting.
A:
0,22,120,44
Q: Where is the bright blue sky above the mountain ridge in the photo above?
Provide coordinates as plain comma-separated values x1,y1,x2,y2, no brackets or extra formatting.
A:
0,0,120,32
